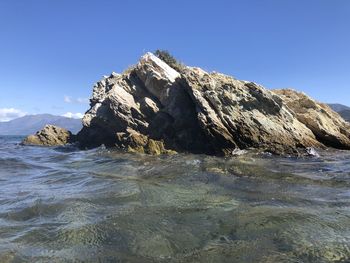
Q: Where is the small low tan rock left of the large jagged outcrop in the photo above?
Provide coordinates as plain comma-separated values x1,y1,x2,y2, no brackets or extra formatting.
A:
22,125,75,146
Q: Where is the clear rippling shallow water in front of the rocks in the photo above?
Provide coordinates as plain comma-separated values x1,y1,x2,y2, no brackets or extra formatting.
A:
0,137,350,263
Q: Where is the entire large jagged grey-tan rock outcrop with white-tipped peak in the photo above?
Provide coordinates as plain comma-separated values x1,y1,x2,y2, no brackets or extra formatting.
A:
78,53,349,155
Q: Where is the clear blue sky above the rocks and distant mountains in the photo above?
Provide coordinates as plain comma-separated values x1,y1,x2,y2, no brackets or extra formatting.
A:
0,0,350,120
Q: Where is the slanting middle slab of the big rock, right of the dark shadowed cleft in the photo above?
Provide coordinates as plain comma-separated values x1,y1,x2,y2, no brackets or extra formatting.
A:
179,68,322,157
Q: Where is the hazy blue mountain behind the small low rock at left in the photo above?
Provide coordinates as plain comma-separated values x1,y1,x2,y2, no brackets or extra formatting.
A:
0,114,82,135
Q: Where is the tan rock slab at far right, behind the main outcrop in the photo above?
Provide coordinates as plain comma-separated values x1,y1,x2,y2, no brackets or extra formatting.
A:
273,89,350,149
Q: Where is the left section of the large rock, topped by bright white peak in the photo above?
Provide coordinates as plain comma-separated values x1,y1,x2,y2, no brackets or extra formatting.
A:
78,53,213,154
